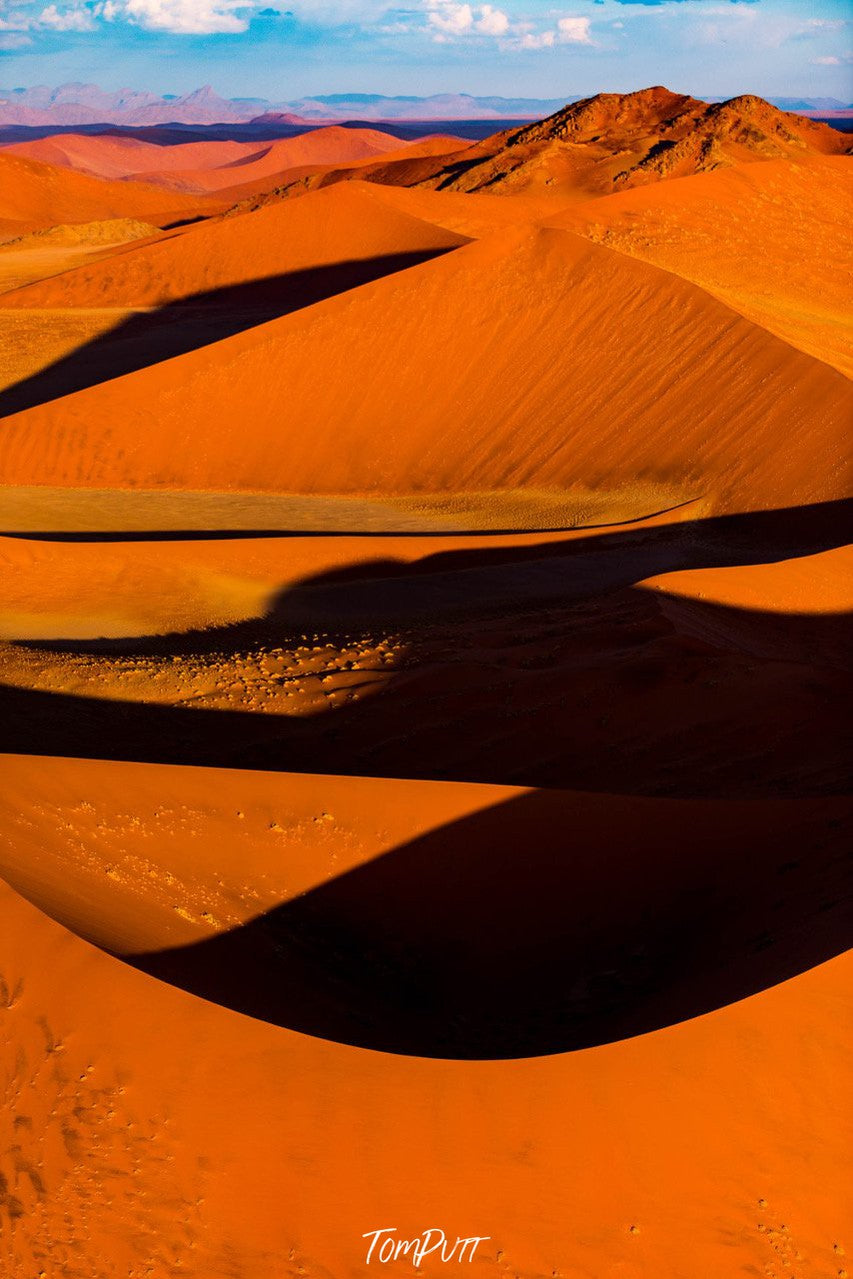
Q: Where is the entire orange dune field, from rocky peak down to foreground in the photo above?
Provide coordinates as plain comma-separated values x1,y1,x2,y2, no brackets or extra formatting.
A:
0,88,853,1279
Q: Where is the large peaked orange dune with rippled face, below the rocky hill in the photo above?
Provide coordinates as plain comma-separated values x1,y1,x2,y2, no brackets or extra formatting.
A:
0,229,850,510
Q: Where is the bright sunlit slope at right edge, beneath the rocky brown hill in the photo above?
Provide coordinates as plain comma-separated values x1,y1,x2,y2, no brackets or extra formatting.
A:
549,155,853,375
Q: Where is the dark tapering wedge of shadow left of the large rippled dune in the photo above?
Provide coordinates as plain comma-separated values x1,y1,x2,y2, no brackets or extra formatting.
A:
0,248,451,418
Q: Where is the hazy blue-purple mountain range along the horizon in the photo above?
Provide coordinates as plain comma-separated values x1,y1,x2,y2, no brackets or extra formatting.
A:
0,83,853,127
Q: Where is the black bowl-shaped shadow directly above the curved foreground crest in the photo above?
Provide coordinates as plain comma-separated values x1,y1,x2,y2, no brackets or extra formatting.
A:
130,792,853,1059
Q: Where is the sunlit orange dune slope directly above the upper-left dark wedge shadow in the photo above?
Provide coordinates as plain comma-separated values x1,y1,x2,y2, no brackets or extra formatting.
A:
3,185,466,308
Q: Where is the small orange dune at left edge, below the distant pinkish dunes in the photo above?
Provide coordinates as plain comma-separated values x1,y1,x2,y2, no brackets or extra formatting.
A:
0,152,223,238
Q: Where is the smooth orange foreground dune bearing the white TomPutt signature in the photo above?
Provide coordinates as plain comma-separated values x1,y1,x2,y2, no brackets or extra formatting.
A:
0,869,849,1279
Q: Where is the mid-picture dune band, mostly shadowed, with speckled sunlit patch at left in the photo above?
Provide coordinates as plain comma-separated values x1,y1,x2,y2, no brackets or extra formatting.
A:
0,498,849,798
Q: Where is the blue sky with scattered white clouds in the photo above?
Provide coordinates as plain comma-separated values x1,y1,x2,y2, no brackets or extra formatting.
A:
0,0,853,102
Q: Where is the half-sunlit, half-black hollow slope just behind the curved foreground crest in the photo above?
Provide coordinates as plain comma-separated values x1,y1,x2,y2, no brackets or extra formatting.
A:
3,760,853,1058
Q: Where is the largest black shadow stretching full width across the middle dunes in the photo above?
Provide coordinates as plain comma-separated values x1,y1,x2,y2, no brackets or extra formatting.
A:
0,503,853,798
